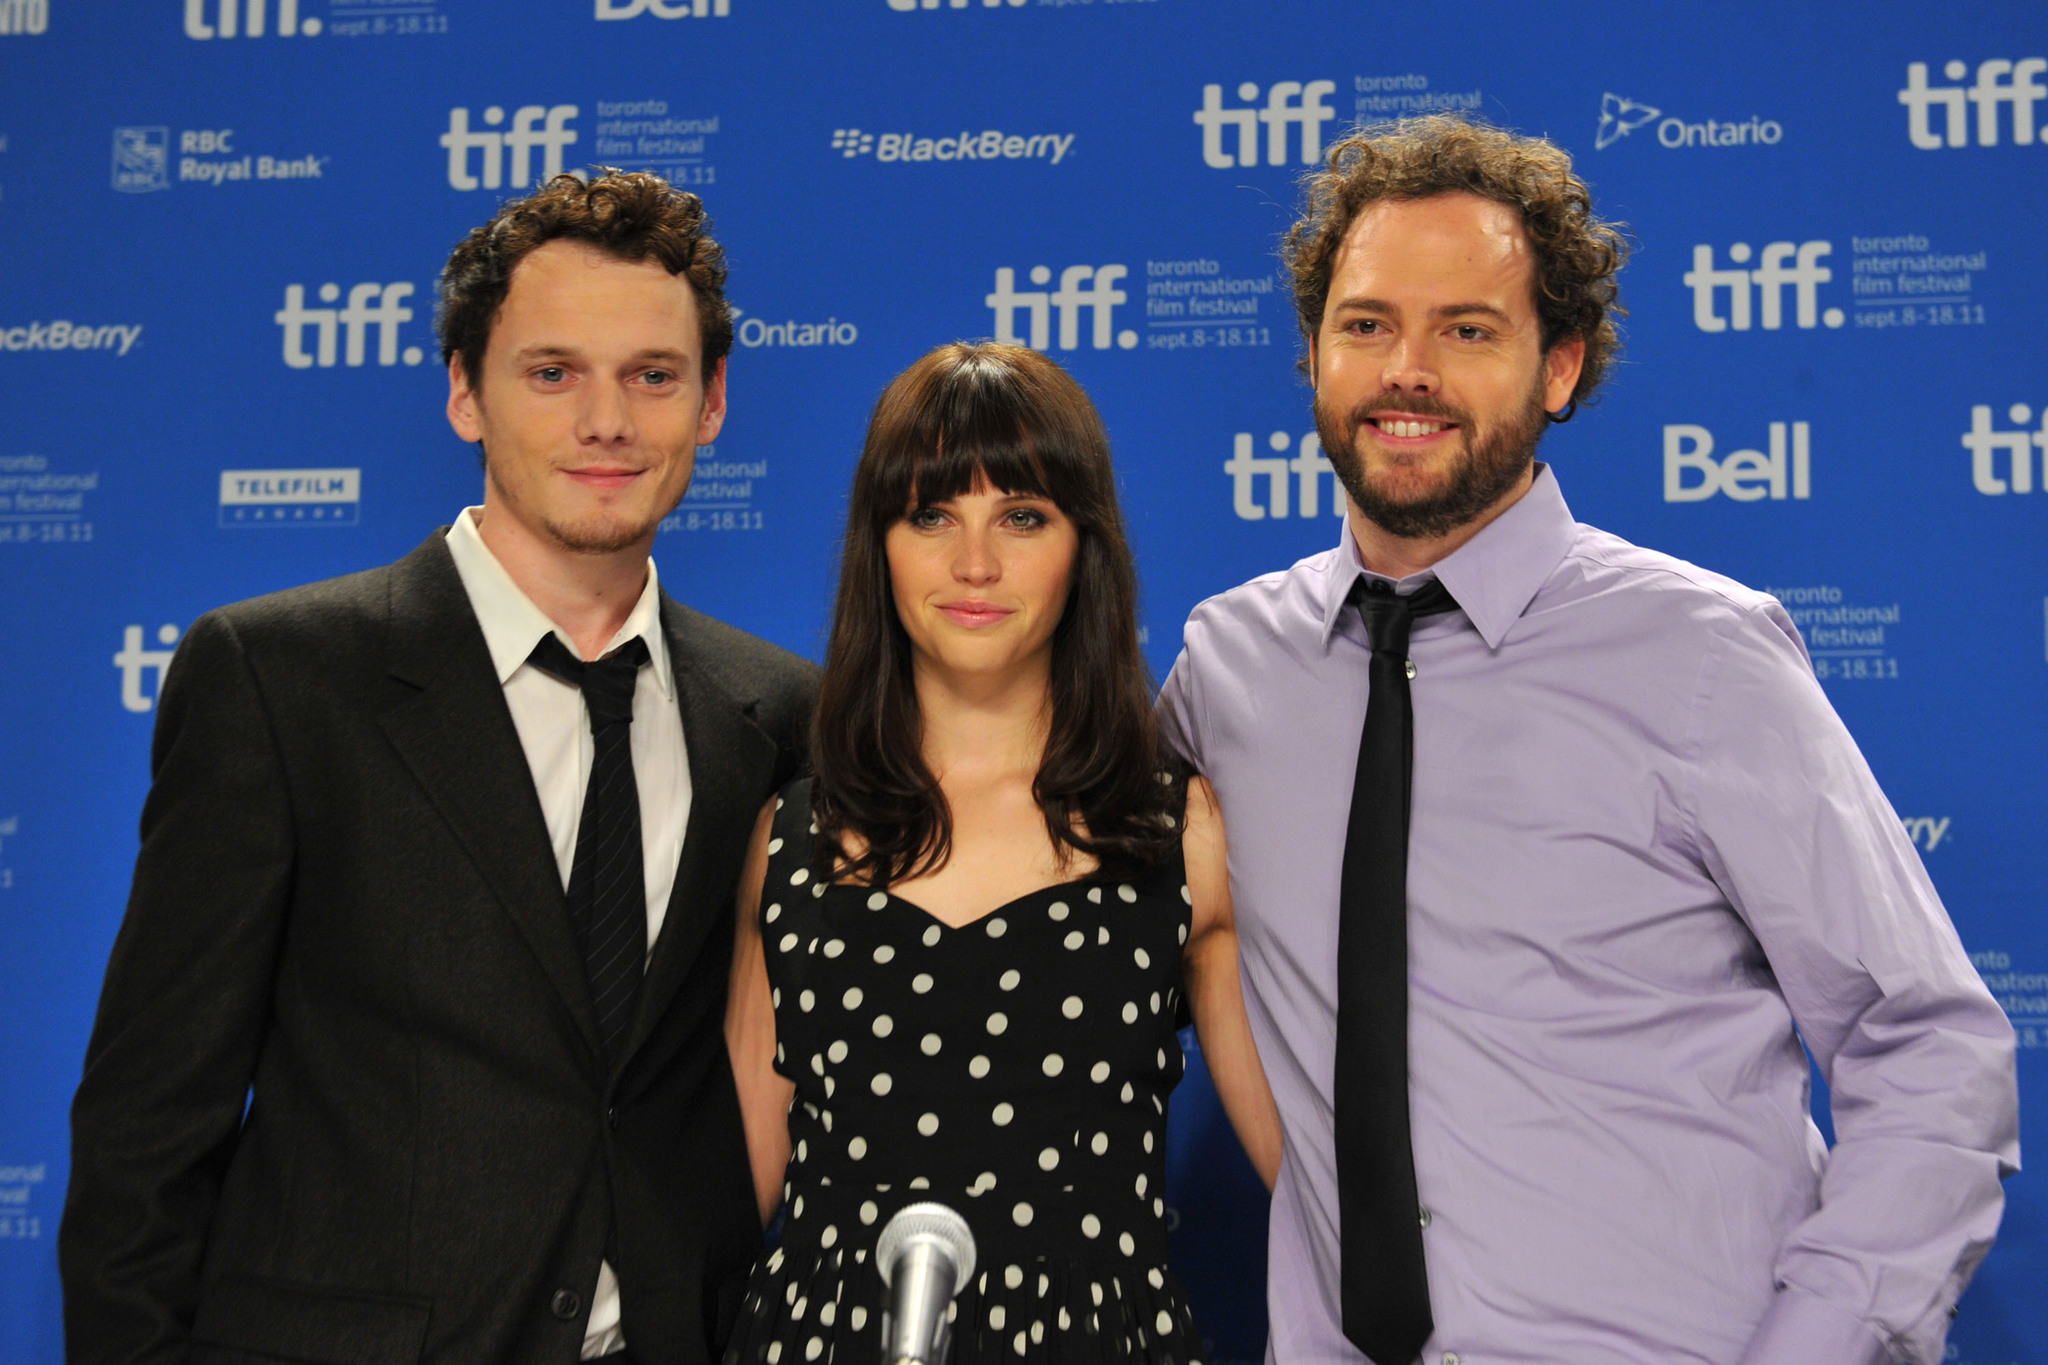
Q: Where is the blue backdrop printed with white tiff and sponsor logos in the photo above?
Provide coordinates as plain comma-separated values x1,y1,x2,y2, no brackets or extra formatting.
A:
0,0,2048,1365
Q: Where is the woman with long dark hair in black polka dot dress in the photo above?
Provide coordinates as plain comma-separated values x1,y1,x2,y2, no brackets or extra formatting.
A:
725,346,1280,1365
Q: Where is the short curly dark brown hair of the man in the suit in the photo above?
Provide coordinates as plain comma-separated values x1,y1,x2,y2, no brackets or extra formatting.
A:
434,166,733,389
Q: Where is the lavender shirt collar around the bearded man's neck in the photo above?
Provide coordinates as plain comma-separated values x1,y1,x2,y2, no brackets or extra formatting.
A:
1323,463,1577,649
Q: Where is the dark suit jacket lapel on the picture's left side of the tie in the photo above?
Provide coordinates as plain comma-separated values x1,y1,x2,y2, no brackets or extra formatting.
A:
379,532,602,1058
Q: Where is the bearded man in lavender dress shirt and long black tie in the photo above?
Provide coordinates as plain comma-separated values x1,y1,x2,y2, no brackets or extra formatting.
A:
1159,117,2019,1365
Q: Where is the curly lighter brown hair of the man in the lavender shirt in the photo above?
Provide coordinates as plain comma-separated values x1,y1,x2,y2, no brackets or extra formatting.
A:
1280,115,1628,422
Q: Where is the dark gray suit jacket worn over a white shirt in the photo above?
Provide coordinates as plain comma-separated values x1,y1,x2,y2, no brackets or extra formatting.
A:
59,534,817,1365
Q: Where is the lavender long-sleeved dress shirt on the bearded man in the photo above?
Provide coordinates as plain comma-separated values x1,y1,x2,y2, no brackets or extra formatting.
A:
1159,465,2019,1365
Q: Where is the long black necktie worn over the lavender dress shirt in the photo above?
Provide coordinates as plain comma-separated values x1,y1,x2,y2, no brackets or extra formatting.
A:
1335,577,1458,1365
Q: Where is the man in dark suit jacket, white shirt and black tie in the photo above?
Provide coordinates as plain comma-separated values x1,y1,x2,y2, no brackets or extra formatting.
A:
59,174,815,1365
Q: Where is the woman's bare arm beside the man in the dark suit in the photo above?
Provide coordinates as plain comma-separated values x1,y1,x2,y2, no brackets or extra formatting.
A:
725,798,797,1228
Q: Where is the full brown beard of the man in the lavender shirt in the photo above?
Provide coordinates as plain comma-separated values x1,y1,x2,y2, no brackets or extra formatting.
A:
1315,375,1550,540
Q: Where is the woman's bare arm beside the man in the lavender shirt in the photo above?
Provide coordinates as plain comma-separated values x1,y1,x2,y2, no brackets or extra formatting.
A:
1182,778,1280,1189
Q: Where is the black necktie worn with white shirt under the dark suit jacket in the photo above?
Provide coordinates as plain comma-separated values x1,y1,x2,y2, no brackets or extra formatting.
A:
528,632,647,1062
